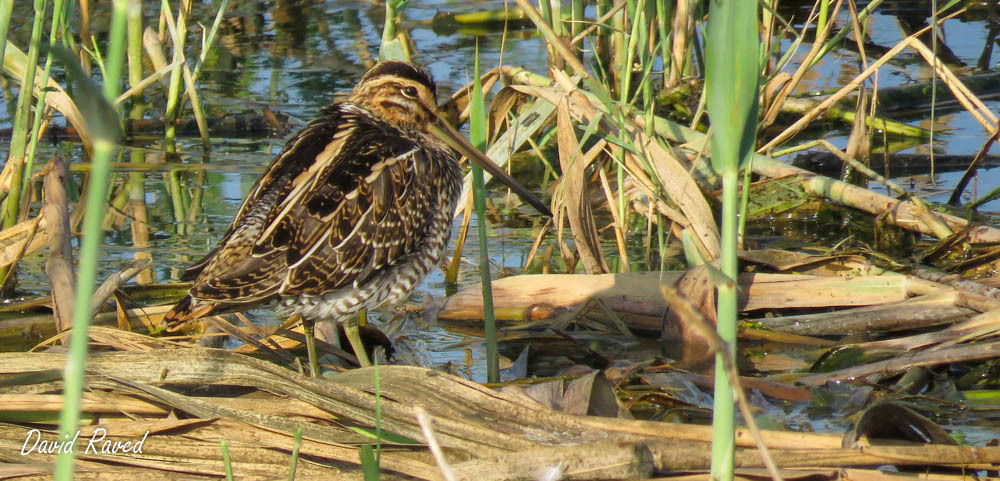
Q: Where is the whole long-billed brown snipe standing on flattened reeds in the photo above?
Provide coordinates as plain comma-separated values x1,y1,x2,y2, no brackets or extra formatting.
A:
165,61,548,375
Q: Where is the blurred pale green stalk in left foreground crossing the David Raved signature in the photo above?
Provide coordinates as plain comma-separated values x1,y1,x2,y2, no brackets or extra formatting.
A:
54,0,128,481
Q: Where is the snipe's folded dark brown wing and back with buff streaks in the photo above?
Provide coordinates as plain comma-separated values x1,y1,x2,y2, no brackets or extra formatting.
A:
175,106,438,319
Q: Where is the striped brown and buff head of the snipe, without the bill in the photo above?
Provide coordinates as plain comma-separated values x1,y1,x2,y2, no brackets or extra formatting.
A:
350,60,438,130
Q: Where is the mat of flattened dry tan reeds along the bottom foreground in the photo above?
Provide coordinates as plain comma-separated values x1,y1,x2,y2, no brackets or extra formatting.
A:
0,348,1000,480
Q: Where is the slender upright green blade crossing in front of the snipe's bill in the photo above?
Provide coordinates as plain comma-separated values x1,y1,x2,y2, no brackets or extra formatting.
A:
469,45,498,382
